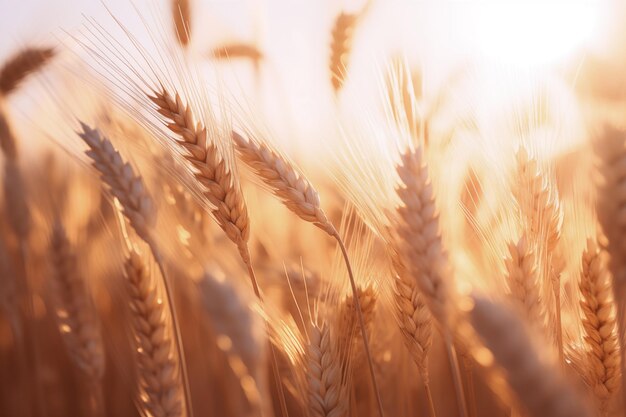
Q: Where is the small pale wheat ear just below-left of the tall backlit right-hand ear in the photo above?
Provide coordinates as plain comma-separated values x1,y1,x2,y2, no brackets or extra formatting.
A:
504,236,543,325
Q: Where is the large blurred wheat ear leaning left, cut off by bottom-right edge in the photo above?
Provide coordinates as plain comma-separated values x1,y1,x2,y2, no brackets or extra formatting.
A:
470,296,591,417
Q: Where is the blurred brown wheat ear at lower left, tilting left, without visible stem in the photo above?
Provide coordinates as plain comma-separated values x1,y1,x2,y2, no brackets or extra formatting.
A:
50,221,105,381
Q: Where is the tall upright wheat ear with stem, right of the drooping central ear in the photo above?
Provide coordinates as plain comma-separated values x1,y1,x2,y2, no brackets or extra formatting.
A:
393,148,467,417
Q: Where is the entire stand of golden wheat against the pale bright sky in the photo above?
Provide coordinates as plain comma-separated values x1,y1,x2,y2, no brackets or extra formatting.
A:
0,0,626,417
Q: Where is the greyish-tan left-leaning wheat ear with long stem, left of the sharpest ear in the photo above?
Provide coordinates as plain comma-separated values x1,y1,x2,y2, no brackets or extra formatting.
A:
78,122,193,415
